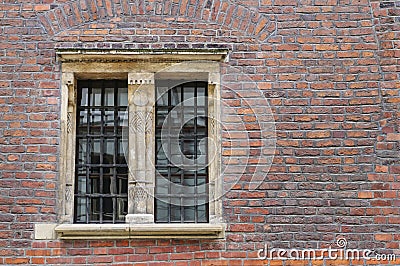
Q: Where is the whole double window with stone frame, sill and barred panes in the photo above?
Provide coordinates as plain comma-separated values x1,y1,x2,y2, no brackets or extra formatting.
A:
55,49,227,239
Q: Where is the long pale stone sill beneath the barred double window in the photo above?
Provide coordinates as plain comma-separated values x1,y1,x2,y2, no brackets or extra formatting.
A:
54,224,225,240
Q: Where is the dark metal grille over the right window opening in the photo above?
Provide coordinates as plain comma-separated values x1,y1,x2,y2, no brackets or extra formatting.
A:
155,81,208,223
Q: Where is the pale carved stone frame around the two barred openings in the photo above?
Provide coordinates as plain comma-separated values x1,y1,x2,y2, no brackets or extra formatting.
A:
35,49,228,239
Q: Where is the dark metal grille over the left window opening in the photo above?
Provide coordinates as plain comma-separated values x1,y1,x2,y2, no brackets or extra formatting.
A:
74,80,128,223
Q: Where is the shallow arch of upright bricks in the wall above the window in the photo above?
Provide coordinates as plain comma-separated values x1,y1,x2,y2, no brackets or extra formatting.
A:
38,0,276,42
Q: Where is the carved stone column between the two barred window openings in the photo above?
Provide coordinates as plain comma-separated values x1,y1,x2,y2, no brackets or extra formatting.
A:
126,73,155,223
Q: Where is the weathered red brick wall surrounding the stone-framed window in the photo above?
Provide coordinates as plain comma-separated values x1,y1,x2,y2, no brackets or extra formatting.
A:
0,0,400,265
